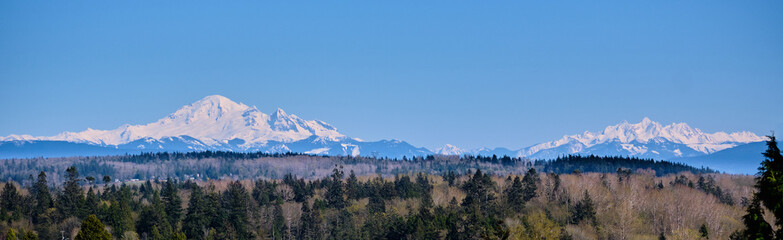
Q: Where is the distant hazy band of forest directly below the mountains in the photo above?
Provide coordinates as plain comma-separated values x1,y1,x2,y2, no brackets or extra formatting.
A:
0,151,715,185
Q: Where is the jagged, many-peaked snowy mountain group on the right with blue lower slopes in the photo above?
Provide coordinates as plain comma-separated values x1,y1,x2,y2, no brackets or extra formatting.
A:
435,118,765,159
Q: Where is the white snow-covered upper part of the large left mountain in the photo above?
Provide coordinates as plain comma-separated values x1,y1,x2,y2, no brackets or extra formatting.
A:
4,95,343,148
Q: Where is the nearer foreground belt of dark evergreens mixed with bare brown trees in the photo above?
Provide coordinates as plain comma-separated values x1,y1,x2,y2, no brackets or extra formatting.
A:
0,160,754,239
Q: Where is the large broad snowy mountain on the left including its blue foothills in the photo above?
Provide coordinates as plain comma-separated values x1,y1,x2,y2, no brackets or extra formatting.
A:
0,95,431,157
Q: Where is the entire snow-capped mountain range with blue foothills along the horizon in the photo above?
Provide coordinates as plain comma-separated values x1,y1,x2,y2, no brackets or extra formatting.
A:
0,95,765,173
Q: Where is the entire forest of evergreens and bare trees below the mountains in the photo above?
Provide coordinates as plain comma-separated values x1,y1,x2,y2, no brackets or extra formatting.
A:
0,138,783,239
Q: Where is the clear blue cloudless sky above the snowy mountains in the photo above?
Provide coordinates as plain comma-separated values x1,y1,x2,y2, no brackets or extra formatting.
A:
0,0,783,149
